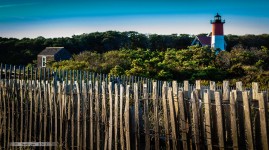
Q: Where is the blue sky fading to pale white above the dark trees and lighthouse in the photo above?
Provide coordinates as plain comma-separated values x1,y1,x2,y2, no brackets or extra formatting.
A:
0,0,269,38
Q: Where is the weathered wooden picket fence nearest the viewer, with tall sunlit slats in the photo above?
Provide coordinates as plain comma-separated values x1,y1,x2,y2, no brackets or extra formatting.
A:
0,79,268,150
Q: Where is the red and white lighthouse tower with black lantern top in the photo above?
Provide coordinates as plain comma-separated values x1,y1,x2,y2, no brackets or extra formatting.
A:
210,13,225,50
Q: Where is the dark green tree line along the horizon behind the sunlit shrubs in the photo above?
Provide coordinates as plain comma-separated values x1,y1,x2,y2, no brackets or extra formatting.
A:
0,31,269,65
